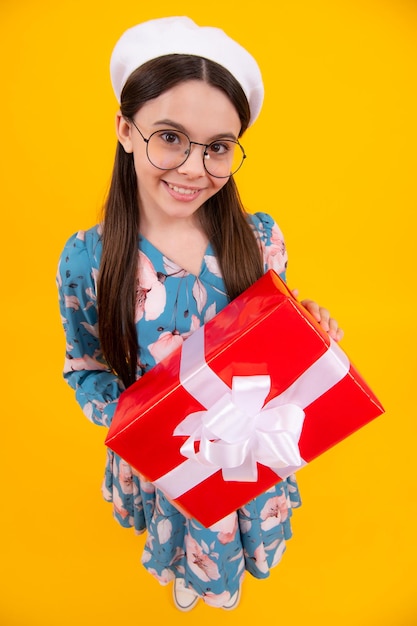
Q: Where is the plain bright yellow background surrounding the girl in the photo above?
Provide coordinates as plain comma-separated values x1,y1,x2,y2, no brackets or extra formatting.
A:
0,0,417,626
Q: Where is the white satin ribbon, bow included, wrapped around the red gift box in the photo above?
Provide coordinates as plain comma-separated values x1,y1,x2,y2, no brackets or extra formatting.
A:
155,327,349,499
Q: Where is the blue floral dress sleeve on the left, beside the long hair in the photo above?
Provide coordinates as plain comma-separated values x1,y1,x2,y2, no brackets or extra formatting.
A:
57,231,123,426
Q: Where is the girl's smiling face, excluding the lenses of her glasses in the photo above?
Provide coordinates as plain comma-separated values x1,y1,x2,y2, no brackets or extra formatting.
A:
117,80,241,225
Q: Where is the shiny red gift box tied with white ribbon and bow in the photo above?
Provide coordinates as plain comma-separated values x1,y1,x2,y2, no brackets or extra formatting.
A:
105,270,384,526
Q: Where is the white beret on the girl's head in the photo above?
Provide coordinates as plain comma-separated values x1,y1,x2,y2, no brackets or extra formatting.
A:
110,17,264,124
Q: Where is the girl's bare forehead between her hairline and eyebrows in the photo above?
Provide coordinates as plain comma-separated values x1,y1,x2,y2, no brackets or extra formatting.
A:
136,80,241,137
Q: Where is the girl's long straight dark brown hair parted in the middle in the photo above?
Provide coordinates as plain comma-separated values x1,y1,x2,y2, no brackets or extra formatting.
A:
97,54,263,387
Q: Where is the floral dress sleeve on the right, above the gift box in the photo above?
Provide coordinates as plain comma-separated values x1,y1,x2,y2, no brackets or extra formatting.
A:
251,213,288,280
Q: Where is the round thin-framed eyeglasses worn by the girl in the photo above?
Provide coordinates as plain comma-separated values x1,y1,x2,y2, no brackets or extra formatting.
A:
131,120,246,178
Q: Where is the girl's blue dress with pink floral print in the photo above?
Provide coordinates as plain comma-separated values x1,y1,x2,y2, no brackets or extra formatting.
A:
57,213,300,606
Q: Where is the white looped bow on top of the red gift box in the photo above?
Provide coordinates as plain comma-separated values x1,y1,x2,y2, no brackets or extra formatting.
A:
174,376,304,482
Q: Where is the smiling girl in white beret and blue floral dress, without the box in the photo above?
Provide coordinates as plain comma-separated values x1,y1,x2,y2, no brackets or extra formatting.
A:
58,18,342,610
